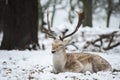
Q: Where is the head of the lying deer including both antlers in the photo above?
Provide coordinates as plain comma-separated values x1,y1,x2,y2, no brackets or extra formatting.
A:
45,11,85,53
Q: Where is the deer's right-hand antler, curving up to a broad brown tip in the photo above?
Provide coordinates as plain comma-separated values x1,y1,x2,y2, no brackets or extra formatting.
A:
60,12,85,40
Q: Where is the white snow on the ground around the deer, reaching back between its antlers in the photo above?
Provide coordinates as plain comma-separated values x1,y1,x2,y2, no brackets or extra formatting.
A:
0,6,120,80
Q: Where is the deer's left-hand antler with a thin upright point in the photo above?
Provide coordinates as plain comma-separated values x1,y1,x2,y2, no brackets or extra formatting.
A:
44,10,56,39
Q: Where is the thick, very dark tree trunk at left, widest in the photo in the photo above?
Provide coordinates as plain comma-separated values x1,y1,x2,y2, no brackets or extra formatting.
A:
0,0,39,50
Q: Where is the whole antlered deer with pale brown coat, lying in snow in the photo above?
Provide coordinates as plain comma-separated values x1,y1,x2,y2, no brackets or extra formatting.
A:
45,12,112,74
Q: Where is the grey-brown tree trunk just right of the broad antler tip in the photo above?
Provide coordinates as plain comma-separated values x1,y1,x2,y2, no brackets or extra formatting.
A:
82,0,92,27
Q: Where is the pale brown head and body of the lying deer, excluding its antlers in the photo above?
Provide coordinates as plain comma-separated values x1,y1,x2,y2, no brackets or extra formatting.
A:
52,39,112,73
